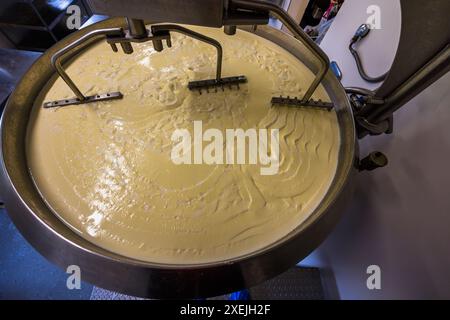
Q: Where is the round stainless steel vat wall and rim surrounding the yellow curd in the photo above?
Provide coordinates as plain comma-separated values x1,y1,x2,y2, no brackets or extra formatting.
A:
0,19,357,298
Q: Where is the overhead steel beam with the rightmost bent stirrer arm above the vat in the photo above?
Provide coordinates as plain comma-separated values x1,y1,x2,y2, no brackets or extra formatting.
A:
90,0,330,106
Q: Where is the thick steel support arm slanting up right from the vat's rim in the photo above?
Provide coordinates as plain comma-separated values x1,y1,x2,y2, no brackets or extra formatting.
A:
357,0,450,138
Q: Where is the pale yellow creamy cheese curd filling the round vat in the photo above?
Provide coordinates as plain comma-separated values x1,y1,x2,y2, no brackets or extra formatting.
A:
27,27,340,264
